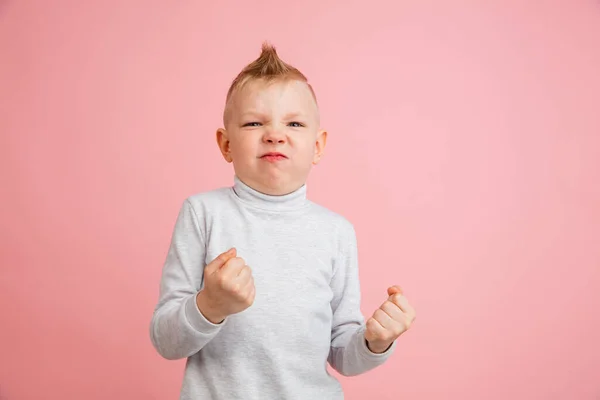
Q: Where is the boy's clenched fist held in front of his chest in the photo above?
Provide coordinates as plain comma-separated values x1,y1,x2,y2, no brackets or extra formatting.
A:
196,249,256,324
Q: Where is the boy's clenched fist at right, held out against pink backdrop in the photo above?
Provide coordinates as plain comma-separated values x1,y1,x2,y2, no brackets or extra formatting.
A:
365,286,416,353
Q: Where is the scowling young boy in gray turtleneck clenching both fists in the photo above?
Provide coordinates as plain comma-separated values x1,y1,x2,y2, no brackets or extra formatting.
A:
150,44,415,400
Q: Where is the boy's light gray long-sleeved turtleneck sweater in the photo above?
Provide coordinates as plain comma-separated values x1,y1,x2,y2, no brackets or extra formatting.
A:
150,177,395,400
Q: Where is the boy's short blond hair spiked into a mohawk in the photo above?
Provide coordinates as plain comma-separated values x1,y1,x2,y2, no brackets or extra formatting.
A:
223,42,317,121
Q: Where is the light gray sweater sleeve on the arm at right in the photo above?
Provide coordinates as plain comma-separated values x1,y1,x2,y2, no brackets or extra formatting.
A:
328,221,395,376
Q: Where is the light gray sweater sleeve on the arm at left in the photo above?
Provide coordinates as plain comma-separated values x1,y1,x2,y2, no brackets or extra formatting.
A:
150,200,226,360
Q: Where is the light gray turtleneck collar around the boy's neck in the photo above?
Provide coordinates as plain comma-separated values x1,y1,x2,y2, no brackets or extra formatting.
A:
232,176,308,211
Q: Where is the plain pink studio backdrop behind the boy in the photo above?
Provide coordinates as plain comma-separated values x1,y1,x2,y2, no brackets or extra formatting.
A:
0,0,600,400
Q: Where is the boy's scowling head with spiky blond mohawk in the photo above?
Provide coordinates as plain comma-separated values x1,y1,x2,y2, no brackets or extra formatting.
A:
217,44,327,195
